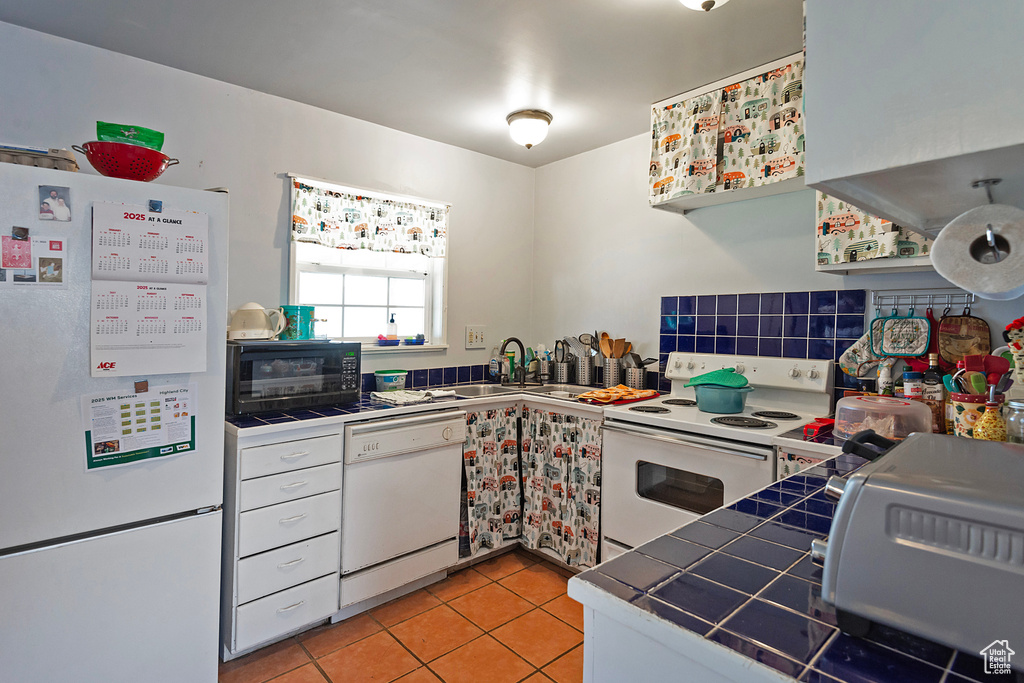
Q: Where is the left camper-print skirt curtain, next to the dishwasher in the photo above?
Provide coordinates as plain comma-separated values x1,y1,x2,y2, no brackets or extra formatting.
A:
460,407,521,555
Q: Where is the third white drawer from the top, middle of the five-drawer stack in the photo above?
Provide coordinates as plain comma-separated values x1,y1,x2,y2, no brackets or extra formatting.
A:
239,490,341,557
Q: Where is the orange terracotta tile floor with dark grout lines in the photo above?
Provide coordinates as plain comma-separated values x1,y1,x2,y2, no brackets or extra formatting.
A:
219,551,583,683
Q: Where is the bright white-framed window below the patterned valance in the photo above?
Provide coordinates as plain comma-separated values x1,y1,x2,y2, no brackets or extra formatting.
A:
290,242,445,345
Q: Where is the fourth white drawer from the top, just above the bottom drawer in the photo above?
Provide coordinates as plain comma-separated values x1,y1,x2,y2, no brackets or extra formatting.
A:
237,531,341,604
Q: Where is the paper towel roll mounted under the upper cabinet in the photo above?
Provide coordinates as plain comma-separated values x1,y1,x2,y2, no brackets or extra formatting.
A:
932,204,1024,300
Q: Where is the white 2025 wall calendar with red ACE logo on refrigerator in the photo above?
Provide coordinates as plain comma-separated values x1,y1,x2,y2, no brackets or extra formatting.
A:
90,203,210,377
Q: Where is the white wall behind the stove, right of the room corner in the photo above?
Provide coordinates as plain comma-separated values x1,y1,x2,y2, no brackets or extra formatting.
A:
534,133,1024,356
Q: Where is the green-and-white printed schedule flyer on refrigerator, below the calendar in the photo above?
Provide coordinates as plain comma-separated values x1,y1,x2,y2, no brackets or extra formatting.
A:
82,384,197,470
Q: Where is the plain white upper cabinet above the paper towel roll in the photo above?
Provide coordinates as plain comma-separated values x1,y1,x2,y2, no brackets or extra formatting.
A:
804,0,1024,233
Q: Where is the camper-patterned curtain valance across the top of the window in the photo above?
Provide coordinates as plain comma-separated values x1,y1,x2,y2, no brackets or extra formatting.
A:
292,177,452,258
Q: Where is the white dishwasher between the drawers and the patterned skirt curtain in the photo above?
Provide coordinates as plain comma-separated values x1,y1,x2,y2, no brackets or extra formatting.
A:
341,411,466,608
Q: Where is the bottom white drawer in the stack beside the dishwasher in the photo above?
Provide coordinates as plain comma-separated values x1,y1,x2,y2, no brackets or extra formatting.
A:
234,574,340,651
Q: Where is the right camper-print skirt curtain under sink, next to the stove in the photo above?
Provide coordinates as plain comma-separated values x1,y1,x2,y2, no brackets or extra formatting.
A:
522,409,601,566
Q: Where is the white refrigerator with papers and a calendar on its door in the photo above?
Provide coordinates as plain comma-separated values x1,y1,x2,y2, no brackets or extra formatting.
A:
0,160,228,683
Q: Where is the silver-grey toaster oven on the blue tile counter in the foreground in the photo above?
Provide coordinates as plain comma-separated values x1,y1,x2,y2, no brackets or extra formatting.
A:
812,433,1024,673
